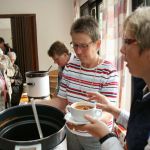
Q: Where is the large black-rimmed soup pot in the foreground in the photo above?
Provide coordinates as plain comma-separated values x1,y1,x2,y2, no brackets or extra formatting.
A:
0,104,67,150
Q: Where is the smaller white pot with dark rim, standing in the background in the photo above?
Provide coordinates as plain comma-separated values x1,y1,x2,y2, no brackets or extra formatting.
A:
26,71,50,98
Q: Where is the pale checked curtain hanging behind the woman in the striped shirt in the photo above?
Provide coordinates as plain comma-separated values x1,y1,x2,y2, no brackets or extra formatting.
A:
100,0,131,110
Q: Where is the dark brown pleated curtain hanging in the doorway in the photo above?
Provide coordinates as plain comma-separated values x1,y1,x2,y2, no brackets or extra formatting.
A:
11,15,39,82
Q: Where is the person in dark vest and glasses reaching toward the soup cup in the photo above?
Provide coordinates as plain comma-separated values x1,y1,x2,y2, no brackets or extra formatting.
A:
73,7,150,150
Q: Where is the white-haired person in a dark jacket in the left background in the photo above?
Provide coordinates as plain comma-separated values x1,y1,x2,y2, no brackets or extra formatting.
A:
7,52,23,106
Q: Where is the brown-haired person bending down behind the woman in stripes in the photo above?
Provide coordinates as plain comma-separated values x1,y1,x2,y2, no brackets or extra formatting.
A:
47,41,75,93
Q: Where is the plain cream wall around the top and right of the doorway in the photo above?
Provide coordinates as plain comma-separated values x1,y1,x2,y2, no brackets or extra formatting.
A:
0,0,74,70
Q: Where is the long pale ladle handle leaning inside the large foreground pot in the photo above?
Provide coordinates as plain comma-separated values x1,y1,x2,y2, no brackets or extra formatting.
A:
30,98,43,139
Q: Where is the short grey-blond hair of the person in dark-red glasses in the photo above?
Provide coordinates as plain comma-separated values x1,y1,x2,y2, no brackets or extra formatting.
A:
124,7,150,53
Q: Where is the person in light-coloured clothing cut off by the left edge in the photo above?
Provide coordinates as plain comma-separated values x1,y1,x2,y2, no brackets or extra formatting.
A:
0,48,15,111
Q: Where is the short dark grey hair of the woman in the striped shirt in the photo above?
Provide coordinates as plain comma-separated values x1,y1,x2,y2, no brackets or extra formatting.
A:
70,16,100,42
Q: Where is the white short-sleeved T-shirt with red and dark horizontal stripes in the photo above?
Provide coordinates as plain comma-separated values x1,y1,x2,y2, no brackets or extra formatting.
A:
58,58,118,103
